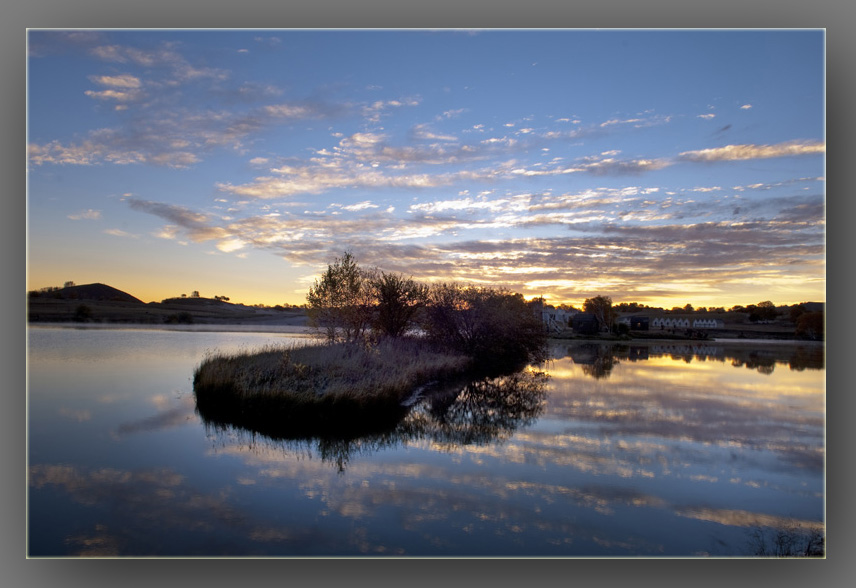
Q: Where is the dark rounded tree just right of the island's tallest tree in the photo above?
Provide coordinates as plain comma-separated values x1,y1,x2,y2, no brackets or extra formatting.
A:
372,272,428,337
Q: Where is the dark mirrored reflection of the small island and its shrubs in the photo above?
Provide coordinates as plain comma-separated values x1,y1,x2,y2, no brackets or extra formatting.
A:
196,369,548,472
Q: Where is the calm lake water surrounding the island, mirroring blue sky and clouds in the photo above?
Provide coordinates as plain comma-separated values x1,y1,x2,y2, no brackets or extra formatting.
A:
28,327,825,557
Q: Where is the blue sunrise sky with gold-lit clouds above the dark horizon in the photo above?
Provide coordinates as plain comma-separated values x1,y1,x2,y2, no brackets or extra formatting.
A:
27,29,826,308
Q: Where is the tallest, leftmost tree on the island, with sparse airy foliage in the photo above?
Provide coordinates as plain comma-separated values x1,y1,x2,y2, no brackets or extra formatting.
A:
306,251,373,342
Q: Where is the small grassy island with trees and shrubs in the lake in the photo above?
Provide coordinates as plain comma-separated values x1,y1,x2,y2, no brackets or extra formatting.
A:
194,253,546,430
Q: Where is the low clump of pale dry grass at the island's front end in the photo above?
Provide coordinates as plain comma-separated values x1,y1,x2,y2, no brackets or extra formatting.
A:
193,338,471,433
